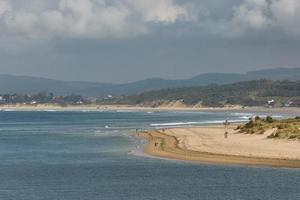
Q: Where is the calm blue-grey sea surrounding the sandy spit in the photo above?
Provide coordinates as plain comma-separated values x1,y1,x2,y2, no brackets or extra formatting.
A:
0,111,300,200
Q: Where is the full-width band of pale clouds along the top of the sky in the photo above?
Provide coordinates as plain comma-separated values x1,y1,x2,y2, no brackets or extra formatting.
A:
0,0,300,41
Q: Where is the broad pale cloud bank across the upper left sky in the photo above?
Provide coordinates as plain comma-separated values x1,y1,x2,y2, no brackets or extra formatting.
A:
0,0,189,38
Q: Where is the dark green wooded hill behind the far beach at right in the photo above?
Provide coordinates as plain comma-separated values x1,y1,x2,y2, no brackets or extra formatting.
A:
115,80,300,107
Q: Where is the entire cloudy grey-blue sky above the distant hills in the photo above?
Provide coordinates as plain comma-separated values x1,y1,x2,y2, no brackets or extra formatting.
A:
0,0,300,83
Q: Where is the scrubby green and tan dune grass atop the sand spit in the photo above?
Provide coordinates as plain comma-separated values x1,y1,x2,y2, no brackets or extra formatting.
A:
237,116,300,139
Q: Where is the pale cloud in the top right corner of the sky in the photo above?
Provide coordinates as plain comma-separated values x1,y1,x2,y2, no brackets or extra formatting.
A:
230,0,300,36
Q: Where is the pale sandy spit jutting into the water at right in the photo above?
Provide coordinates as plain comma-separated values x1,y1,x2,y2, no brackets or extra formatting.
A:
139,125,300,168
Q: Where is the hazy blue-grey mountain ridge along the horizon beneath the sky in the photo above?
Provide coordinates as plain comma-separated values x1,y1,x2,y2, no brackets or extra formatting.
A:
0,68,300,96
